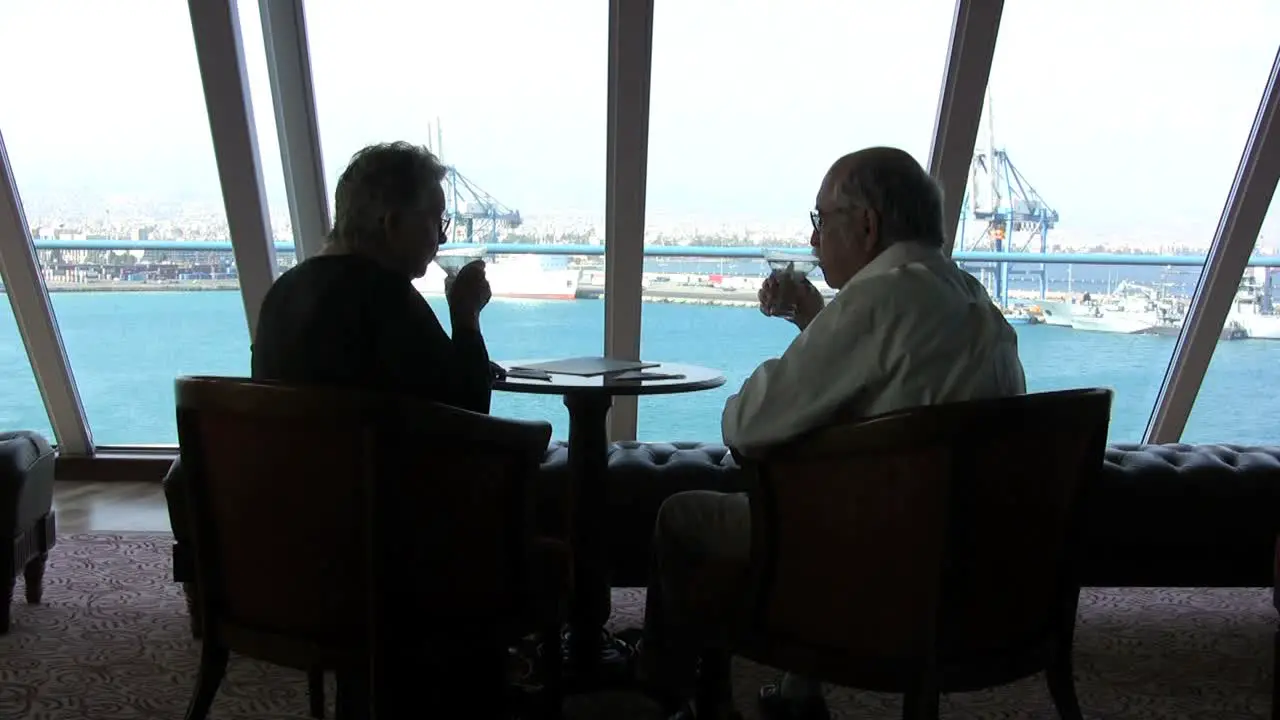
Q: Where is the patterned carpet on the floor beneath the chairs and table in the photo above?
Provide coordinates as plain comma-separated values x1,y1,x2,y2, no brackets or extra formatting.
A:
0,534,1276,720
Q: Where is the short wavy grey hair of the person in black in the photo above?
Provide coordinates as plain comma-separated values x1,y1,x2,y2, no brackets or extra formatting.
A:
329,142,447,247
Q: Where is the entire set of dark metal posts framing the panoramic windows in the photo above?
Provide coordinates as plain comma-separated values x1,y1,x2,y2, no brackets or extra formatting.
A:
0,0,1280,479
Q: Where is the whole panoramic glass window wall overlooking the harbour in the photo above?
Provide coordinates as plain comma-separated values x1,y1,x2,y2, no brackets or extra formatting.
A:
0,0,1280,446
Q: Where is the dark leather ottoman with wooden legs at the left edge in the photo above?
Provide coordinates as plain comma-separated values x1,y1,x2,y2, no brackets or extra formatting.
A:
0,432,56,634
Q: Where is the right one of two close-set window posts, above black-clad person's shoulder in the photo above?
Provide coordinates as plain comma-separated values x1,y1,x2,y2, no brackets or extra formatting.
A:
259,0,330,263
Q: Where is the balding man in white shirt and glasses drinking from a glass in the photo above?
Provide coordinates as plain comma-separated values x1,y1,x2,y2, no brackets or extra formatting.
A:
640,147,1025,719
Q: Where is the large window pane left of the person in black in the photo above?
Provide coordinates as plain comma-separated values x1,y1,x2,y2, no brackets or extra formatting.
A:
0,0,259,445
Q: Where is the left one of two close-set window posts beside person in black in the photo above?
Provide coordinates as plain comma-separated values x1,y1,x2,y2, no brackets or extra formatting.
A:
187,0,275,338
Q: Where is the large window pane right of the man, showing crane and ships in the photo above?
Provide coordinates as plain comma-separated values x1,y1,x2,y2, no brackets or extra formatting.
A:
956,0,1280,441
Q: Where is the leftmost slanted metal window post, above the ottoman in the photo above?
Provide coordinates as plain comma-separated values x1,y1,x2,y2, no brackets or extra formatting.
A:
0,133,93,455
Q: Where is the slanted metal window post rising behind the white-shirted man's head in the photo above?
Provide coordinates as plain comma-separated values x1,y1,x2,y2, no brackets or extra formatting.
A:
929,0,1005,255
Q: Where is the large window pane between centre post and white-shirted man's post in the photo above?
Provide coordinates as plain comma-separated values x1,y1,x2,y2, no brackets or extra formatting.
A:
639,0,955,441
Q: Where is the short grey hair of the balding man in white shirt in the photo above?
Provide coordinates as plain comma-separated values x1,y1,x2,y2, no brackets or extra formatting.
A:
836,147,946,247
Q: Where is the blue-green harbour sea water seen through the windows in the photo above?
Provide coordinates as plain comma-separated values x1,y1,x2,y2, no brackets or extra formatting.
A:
0,292,1280,445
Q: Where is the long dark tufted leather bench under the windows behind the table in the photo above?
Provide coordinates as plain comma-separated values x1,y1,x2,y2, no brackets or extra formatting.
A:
539,442,1280,587
